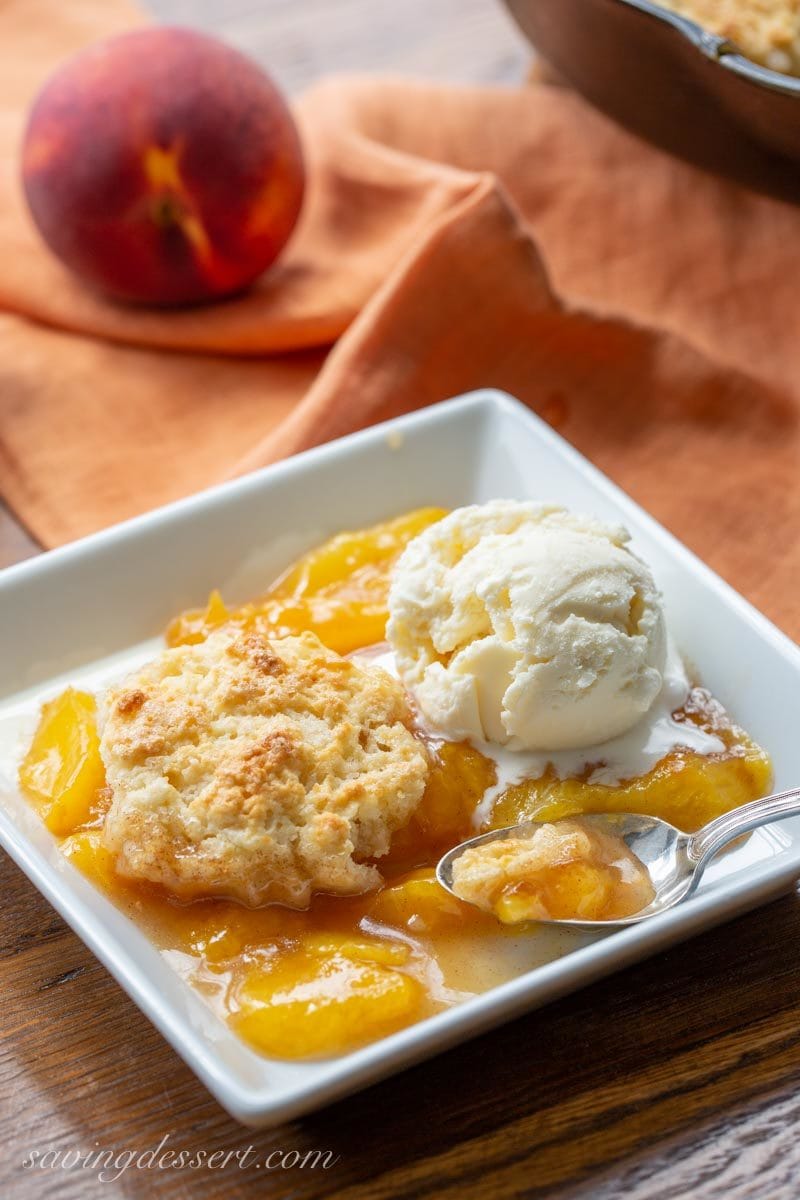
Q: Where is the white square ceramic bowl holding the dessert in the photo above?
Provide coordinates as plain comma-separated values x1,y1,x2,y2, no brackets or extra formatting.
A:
0,391,800,1127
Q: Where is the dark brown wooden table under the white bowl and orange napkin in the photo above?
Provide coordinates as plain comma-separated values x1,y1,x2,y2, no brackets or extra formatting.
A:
0,0,800,1200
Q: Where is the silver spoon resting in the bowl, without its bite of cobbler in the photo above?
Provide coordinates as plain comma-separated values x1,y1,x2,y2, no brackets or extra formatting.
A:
437,787,800,932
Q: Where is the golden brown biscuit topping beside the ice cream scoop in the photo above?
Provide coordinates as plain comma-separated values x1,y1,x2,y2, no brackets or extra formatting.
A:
101,631,428,906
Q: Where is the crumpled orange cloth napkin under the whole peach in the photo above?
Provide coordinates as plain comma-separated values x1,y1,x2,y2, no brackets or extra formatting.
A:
0,0,800,636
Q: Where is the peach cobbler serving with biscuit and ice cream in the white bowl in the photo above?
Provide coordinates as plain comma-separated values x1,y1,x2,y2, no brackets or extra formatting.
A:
19,500,771,1058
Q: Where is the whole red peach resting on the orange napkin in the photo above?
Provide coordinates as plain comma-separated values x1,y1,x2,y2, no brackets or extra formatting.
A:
22,26,305,305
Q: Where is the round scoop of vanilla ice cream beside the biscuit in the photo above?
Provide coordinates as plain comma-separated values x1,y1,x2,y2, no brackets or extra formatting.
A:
386,500,667,750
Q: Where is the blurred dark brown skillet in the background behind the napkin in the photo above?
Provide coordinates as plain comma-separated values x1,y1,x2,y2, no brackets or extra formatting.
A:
505,0,800,203
